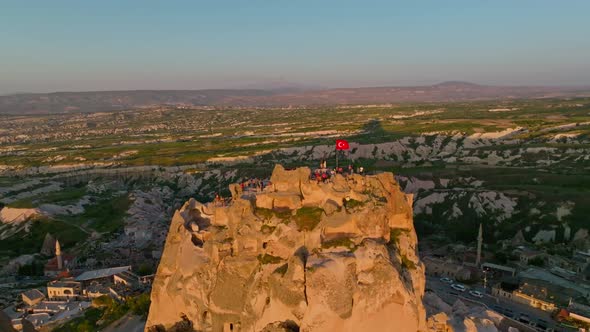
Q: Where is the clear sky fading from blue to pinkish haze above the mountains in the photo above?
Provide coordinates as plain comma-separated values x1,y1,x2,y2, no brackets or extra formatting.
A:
0,0,590,94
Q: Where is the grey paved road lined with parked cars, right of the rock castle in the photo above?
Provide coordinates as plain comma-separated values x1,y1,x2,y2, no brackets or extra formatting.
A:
426,276,571,331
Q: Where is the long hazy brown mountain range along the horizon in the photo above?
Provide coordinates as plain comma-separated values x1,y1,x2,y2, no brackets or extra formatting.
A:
0,82,590,114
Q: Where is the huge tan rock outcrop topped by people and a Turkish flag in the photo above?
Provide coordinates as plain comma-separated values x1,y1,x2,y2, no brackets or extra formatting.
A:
146,165,427,332
